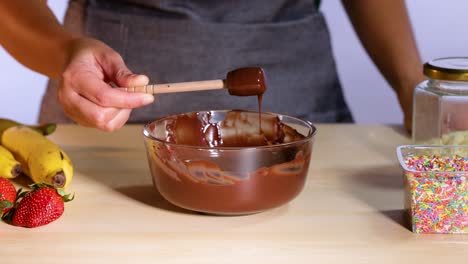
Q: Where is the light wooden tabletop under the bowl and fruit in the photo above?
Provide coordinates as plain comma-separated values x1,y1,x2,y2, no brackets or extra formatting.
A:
0,125,468,264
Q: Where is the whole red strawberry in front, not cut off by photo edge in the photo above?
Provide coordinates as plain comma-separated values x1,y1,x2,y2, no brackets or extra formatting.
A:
11,184,73,227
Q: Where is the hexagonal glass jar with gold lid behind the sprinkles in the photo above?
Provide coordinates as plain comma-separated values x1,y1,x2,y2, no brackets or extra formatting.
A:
412,57,468,145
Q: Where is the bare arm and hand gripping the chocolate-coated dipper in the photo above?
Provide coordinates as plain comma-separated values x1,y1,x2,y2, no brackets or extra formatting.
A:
0,0,154,131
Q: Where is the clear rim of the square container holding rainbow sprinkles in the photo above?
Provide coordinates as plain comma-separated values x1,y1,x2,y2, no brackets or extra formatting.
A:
396,144,468,175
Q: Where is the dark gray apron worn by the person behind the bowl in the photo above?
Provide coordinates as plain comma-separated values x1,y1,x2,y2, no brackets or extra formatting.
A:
40,0,353,123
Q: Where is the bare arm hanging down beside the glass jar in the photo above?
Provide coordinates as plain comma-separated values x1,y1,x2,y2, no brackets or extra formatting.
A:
342,0,424,130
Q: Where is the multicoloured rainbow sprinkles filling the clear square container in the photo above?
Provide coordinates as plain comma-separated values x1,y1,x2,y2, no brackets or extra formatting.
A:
405,155,468,234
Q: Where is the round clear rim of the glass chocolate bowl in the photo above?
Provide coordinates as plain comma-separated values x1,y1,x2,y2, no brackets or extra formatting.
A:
142,109,317,150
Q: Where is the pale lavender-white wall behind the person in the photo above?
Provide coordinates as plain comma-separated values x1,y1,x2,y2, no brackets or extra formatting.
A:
0,0,468,124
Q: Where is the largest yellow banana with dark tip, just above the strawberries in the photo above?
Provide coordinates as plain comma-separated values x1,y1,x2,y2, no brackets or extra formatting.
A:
1,126,73,189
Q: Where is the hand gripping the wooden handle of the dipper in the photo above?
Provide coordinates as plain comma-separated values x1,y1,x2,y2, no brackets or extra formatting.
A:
58,38,154,131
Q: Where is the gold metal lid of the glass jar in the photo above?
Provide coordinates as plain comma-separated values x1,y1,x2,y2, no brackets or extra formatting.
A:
423,57,468,81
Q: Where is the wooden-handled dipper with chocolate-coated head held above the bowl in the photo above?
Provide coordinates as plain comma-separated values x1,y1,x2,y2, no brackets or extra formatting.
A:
117,67,266,96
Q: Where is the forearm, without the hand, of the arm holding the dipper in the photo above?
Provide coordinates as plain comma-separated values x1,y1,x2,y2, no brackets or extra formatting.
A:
0,0,74,79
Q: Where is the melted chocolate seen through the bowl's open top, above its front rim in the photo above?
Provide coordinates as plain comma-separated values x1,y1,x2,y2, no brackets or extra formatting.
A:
165,110,304,147
